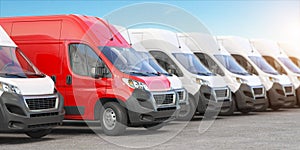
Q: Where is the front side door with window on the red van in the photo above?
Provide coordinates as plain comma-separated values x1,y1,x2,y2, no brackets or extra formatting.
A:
65,43,108,120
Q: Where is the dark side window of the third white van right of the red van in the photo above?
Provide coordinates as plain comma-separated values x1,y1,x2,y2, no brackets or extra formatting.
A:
195,53,225,76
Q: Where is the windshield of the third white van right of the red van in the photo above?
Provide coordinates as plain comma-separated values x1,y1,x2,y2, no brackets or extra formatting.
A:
214,55,249,75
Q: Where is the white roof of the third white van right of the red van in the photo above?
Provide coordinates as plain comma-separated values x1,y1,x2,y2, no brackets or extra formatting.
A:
179,32,230,55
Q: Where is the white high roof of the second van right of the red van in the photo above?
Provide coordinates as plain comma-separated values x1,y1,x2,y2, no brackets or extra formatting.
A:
128,28,192,53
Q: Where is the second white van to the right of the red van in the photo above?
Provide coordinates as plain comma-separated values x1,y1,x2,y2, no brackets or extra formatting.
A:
129,29,231,116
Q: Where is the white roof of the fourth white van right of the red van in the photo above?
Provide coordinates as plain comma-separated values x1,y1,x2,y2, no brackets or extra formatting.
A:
217,36,261,56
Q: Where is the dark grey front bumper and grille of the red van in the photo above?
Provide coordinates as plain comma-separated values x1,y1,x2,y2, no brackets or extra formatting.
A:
125,89,180,126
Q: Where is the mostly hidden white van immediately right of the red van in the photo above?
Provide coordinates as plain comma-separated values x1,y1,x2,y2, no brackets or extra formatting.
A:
115,25,189,120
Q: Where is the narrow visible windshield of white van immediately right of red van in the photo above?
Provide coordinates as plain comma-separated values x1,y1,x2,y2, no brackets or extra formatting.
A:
138,51,170,76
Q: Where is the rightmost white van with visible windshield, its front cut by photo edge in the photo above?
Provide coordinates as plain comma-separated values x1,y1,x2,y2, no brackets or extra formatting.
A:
251,39,300,105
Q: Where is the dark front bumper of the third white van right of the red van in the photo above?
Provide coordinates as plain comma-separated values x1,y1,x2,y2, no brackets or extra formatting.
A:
234,84,268,112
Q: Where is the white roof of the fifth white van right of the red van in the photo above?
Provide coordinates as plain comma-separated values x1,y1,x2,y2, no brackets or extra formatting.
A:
250,39,287,57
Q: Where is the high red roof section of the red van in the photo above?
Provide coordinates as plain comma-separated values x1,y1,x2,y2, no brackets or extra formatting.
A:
0,14,129,47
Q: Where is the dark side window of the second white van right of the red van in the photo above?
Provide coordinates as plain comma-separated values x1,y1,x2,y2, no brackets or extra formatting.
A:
150,51,183,77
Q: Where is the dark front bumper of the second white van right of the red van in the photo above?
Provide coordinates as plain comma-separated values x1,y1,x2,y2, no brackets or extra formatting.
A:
197,85,232,114
